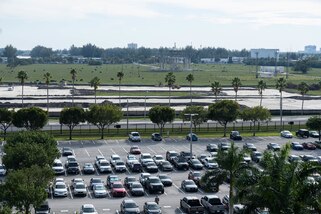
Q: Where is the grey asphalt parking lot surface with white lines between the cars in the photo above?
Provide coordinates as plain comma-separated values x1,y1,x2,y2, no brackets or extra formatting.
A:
49,137,321,213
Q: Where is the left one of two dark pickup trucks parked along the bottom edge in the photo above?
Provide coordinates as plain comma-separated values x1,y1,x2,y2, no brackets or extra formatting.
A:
180,196,205,214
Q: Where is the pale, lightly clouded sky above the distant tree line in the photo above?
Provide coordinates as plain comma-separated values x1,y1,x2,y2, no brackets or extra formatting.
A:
0,0,321,51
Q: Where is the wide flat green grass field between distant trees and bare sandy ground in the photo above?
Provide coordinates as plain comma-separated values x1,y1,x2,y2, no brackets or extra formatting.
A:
0,64,321,88
